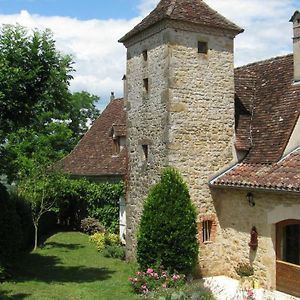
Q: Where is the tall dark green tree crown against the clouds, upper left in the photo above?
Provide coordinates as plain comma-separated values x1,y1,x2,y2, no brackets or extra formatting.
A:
0,25,73,141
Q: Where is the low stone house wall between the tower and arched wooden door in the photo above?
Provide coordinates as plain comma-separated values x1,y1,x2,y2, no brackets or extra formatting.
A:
212,189,300,289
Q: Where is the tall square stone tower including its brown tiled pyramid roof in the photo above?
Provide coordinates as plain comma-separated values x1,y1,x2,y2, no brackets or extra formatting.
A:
120,0,243,273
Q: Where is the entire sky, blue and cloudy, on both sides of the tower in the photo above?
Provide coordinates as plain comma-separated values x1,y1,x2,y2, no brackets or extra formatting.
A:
0,0,300,108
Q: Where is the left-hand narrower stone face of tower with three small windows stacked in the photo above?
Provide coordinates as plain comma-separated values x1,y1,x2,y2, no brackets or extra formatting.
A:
126,27,168,259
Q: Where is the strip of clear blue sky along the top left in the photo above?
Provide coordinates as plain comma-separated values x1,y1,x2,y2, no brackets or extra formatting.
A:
0,0,139,20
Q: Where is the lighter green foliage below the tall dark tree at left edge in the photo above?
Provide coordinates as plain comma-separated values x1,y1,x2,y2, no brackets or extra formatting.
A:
0,122,73,181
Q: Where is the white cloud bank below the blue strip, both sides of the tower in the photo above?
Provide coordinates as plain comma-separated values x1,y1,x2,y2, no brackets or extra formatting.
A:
0,0,298,107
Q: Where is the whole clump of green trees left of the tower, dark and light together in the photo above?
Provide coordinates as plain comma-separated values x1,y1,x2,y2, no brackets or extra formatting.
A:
0,25,99,181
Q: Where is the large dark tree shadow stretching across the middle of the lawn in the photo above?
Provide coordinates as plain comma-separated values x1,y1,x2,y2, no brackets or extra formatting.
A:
13,253,114,283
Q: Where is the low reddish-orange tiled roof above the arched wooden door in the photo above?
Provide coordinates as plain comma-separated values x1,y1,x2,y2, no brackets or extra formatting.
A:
212,149,300,192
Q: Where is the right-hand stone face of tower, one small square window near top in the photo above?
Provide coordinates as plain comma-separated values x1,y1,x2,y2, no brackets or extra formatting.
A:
168,26,234,275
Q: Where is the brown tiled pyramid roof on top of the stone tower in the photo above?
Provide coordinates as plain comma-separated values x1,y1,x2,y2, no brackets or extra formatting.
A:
119,0,244,42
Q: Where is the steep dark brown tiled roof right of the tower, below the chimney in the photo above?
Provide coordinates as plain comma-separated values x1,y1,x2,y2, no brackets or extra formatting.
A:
235,55,300,163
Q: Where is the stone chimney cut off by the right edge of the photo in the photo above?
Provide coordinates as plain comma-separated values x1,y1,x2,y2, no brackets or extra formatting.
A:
290,10,300,83
